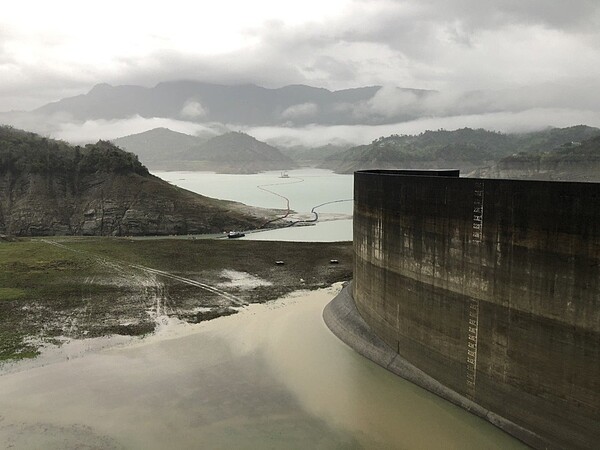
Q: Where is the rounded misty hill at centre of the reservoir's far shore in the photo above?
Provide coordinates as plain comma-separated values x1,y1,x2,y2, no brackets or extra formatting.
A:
177,132,295,173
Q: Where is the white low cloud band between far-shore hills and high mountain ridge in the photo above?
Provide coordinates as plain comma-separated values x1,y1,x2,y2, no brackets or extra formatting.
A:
0,98,600,147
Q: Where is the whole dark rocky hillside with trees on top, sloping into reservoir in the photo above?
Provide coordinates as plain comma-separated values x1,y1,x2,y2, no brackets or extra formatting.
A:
0,127,272,236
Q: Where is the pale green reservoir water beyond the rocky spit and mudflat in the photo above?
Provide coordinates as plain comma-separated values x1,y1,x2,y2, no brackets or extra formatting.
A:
153,169,353,242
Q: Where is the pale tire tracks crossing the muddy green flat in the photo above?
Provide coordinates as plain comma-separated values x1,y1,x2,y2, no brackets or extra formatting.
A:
41,239,248,310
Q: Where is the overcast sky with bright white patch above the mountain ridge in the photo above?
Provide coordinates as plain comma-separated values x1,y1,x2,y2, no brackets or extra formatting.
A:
0,0,600,143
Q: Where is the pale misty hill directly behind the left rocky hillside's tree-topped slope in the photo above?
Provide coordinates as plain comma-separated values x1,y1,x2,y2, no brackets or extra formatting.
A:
111,128,208,166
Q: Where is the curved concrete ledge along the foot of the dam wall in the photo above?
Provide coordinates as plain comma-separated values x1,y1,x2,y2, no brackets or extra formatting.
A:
323,284,558,449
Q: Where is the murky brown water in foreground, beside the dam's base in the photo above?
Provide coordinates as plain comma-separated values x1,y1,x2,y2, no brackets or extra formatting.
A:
0,288,523,449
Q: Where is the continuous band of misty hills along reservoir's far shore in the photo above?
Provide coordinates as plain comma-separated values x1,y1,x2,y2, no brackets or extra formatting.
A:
104,125,600,181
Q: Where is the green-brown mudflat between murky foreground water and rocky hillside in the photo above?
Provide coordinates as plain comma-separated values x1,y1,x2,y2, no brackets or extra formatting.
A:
0,237,352,361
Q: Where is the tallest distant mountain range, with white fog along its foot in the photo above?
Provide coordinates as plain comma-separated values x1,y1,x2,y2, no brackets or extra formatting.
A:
0,81,600,148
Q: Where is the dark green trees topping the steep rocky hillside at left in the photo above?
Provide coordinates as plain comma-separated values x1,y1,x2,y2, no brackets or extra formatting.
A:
0,126,148,178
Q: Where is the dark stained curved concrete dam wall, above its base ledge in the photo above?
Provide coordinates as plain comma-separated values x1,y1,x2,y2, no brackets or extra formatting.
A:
352,171,600,448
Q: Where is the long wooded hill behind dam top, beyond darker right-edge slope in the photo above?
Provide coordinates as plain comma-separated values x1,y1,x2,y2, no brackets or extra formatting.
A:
321,125,600,173
